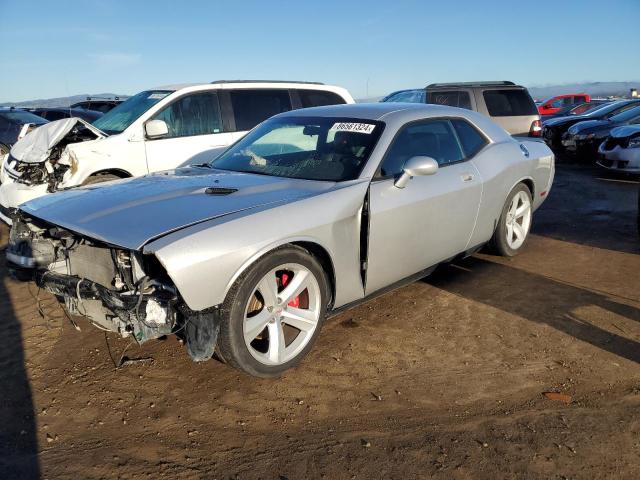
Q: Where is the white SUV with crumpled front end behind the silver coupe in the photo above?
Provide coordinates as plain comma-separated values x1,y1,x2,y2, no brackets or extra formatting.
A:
0,81,354,224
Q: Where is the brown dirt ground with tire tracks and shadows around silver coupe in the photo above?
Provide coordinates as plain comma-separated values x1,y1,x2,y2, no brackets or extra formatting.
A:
0,166,640,480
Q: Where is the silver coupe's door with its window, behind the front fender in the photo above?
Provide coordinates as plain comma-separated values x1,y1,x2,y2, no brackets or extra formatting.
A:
366,119,482,294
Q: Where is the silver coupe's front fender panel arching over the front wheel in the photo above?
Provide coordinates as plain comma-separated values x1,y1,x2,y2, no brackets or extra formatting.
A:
143,181,369,311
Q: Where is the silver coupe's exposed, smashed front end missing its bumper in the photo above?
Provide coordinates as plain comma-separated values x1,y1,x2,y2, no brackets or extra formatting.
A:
6,213,218,361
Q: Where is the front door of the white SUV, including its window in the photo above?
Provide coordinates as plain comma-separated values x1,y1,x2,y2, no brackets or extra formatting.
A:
144,91,233,172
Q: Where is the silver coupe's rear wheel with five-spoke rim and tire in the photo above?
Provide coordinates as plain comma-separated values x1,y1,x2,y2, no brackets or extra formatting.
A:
491,183,532,257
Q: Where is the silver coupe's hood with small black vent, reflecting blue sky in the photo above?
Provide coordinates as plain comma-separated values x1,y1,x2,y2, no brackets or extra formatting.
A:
20,168,335,250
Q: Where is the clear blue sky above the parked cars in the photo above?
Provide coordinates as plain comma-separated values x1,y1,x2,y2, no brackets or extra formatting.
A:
0,0,640,101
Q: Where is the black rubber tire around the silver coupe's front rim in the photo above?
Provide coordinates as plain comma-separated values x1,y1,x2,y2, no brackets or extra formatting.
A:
216,245,329,378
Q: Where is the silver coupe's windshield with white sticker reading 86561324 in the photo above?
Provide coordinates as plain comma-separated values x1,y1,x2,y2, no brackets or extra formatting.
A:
211,117,384,182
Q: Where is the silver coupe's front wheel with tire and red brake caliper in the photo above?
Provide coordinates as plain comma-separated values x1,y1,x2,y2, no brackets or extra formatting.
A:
217,246,329,377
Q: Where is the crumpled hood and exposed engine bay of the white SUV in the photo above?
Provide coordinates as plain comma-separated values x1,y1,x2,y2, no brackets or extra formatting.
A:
4,118,106,192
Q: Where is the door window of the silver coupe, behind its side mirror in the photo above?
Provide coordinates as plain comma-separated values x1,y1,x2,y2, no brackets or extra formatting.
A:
380,119,464,177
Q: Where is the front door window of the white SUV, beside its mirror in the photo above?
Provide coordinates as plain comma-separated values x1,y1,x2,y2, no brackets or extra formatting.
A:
154,92,222,138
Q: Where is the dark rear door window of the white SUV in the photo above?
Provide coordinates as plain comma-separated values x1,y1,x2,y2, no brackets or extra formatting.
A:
230,90,291,132
